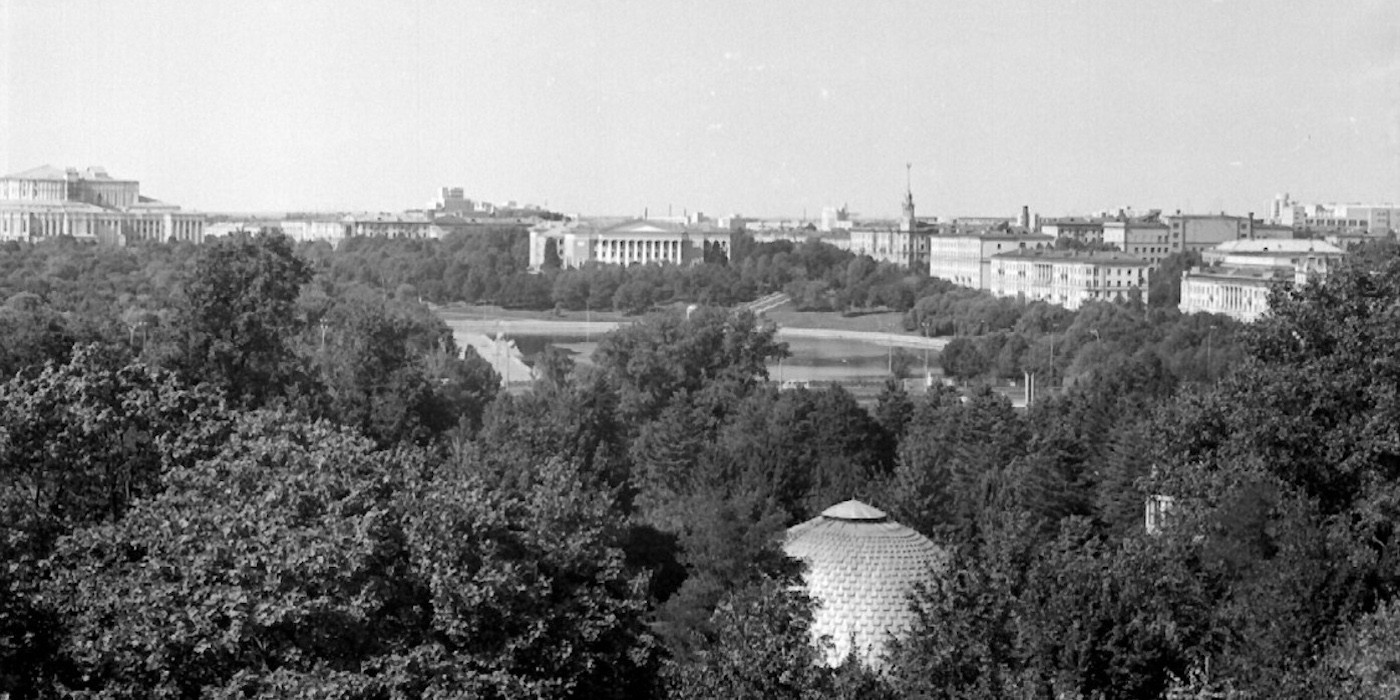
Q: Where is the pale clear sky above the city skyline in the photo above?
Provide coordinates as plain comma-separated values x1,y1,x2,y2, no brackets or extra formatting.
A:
0,0,1400,218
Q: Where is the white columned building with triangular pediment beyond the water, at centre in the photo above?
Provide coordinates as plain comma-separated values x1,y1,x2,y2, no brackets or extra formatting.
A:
529,218,729,269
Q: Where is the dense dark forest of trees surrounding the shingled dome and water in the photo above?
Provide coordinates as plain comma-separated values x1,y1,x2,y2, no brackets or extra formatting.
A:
0,232,1400,699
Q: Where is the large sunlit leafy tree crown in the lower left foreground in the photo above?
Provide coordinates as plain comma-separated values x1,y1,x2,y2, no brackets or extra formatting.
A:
45,413,652,697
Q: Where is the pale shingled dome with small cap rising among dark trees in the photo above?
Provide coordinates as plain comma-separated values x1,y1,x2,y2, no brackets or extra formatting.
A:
783,501,946,668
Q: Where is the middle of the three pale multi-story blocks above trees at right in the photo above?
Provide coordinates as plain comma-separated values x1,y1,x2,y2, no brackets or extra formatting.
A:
988,249,1152,309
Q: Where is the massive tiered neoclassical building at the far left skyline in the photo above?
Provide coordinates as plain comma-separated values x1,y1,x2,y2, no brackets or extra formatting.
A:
0,165,204,245
